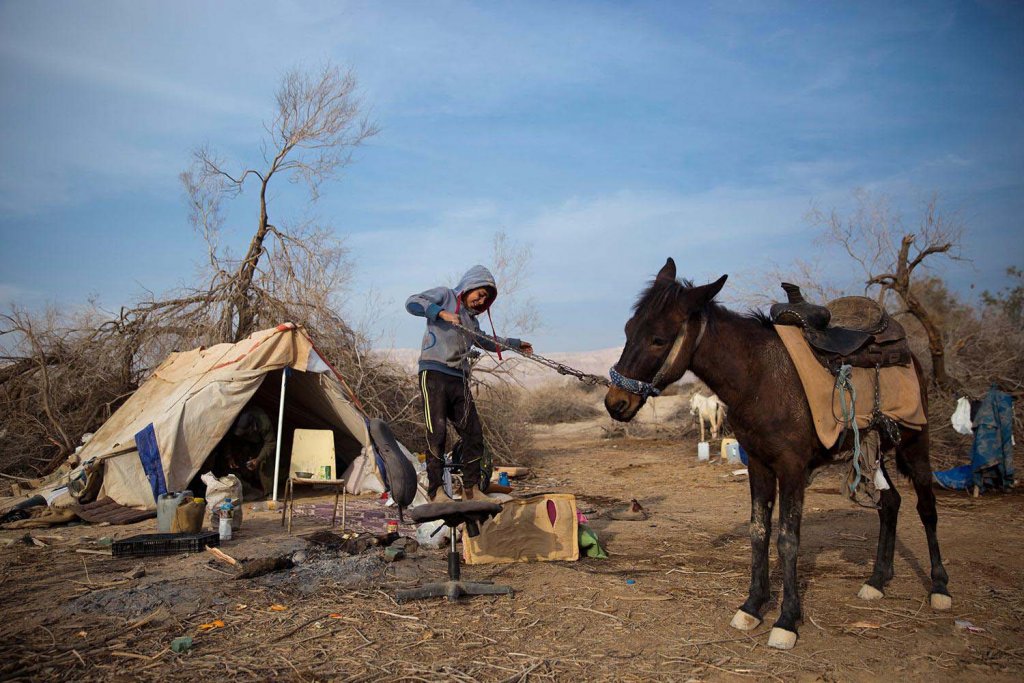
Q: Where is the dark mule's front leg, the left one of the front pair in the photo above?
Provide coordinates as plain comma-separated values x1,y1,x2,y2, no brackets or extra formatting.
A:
731,458,775,631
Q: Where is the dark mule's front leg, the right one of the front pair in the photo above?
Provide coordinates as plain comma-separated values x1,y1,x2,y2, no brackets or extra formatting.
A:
768,467,807,650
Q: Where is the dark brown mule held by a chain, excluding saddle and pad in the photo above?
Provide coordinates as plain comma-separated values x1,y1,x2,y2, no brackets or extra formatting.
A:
604,258,952,649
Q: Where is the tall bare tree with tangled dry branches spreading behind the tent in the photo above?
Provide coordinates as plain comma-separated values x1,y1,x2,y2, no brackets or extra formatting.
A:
0,66,395,481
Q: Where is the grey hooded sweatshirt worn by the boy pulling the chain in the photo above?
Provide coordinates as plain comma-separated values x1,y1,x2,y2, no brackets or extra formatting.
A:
406,265,522,377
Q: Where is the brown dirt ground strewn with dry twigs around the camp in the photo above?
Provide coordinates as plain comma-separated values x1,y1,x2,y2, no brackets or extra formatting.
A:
0,423,1024,682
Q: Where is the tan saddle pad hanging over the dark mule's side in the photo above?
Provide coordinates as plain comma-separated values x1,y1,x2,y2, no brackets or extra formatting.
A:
775,325,928,449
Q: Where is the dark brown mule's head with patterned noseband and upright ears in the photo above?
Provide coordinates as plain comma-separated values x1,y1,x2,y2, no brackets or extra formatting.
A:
604,258,728,422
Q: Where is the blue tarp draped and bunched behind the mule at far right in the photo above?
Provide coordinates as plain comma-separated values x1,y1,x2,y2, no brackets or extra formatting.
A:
934,385,1014,490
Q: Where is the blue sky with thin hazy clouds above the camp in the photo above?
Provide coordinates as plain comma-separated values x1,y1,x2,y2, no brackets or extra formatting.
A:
0,0,1024,353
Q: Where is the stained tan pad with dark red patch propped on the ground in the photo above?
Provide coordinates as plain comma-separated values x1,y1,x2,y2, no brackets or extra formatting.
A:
462,494,580,564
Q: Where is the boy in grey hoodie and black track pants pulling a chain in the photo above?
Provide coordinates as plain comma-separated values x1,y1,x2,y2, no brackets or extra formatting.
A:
406,265,534,502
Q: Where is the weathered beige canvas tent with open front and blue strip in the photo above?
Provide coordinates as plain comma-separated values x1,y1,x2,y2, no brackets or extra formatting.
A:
57,324,384,509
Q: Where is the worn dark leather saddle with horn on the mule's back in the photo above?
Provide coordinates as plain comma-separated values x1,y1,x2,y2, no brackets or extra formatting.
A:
769,283,910,374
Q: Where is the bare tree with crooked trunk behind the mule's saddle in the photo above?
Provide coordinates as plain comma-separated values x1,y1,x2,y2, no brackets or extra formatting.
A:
810,190,964,387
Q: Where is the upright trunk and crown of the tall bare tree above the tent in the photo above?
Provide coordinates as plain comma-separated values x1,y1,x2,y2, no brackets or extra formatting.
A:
180,65,379,341
